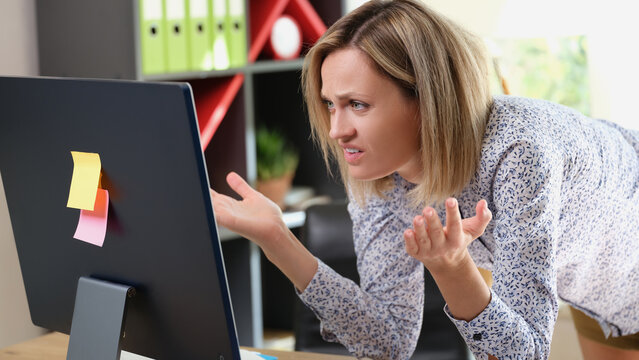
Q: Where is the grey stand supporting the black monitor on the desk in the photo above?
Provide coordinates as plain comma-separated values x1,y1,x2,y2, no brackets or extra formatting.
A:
67,276,135,360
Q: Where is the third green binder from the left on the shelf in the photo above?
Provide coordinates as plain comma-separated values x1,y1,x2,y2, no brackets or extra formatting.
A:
186,0,213,71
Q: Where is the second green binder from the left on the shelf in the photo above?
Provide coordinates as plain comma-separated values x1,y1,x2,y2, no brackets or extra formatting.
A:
164,0,189,72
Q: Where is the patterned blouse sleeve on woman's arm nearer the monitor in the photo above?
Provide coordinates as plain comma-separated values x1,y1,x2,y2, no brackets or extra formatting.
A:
299,187,424,359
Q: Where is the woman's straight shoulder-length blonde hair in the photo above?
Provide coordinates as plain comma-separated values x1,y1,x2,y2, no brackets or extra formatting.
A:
302,0,492,205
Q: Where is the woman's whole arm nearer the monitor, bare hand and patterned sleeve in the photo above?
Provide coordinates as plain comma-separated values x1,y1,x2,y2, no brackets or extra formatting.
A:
211,173,424,359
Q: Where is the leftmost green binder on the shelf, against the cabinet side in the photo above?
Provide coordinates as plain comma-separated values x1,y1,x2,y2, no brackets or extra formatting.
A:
139,0,167,74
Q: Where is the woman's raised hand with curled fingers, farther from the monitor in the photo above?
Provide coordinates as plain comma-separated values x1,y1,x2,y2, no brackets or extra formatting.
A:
404,198,492,273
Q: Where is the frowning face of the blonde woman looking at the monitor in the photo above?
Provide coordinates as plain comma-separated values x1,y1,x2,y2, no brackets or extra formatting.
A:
321,48,422,182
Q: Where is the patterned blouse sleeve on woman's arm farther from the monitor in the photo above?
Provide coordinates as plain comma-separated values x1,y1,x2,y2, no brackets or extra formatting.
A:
445,141,563,360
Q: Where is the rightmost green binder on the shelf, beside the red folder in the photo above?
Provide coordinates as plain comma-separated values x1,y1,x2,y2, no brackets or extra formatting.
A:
226,0,247,67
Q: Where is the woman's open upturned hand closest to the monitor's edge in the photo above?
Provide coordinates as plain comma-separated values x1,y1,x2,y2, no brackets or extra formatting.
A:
211,172,286,248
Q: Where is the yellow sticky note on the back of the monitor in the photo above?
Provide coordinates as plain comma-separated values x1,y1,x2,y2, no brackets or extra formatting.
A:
67,151,102,211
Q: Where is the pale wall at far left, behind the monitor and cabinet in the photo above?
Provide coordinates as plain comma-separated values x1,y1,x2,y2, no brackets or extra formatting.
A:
0,0,44,348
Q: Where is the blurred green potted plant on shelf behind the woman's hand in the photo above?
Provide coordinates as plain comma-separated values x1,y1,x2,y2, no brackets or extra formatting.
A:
255,127,299,209
